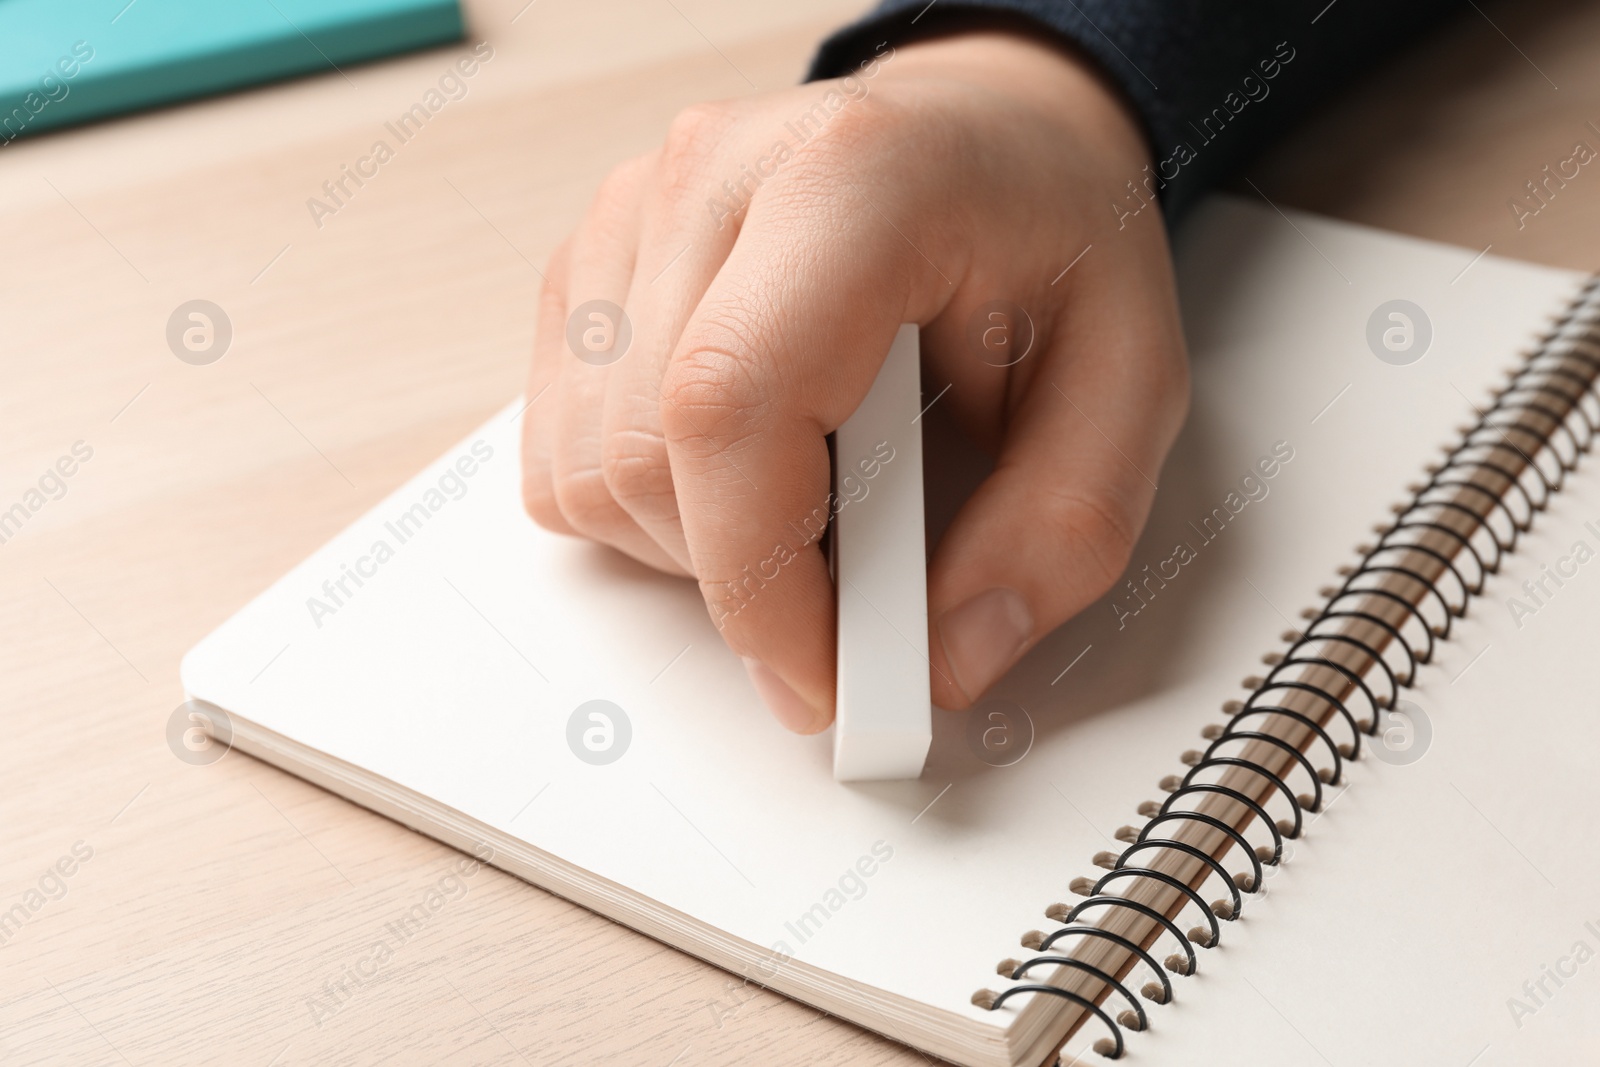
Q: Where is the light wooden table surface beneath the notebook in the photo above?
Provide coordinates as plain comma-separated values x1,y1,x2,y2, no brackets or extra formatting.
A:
0,0,1600,1067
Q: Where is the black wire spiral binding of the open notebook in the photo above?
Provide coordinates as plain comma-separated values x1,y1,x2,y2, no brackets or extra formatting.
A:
973,277,1600,1059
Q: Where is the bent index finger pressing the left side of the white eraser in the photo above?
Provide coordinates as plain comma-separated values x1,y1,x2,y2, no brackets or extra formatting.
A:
661,185,944,733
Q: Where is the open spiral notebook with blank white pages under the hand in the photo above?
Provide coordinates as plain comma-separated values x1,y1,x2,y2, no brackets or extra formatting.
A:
182,198,1600,1067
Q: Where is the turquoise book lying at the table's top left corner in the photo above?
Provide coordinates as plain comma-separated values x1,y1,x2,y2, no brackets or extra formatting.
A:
0,0,464,146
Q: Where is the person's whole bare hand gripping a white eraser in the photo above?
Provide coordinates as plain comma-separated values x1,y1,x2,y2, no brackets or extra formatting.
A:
523,34,1189,733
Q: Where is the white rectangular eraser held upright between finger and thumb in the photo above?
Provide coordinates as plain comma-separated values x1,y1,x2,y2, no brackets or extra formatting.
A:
832,325,933,782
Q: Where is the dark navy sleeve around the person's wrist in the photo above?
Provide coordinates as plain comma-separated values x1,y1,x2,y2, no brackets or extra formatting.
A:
810,0,1462,221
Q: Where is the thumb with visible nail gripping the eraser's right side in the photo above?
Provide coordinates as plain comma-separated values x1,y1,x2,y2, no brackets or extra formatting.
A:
928,246,1187,709
